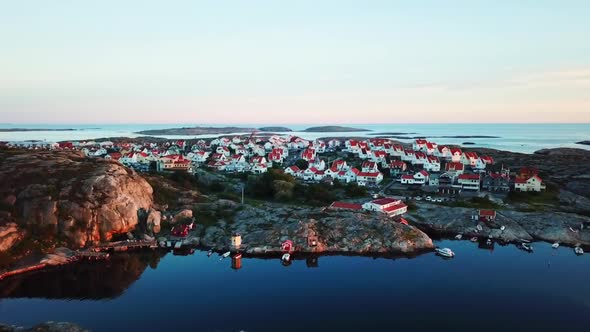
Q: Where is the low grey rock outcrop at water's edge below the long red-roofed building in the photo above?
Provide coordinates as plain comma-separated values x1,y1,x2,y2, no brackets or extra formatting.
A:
191,206,434,255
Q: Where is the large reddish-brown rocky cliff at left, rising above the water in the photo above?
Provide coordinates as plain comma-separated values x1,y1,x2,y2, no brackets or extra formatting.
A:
0,151,153,246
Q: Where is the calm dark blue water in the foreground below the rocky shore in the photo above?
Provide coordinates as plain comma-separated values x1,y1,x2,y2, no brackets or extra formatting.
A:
0,241,590,331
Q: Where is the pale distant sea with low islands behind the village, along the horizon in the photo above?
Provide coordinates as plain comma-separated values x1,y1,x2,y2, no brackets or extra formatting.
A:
0,123,590,153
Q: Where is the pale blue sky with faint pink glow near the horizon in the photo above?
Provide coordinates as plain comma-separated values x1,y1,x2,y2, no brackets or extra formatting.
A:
0,0,590,124
